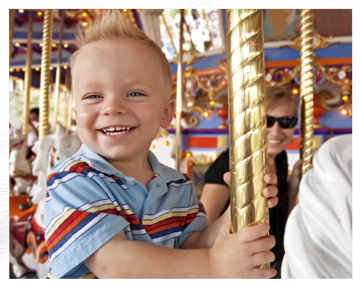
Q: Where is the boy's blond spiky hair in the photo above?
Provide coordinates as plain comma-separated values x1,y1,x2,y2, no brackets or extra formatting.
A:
70,9,172,93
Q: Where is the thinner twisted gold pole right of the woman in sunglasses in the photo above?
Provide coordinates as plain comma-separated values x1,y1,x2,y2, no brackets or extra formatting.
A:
300,9,314,178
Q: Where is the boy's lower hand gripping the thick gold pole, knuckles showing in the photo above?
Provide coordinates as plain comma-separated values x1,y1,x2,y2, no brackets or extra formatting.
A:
209,220,276,278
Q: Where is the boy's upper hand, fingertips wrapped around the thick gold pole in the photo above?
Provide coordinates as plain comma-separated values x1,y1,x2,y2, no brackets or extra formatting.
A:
224,157,279,208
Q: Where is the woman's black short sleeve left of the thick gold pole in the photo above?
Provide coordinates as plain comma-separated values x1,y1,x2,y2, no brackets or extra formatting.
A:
204,150,229,186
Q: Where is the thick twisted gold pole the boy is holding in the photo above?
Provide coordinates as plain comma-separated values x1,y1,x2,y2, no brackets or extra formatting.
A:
226,9,269,268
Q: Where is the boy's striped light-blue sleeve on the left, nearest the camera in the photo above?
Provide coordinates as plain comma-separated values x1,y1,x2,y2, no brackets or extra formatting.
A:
44,171,129,278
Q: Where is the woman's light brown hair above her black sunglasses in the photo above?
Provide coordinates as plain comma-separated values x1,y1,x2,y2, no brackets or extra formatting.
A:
265,87,299,117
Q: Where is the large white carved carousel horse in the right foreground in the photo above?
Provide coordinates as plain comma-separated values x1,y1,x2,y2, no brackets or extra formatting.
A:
281,135,352,278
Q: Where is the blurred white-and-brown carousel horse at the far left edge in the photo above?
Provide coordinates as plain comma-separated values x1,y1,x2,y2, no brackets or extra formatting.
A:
9,128,32,196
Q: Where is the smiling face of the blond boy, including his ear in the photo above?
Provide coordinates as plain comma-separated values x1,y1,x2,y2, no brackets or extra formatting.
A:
72,40,175,165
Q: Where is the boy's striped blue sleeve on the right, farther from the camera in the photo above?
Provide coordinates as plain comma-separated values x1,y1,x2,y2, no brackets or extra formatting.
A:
179,184,210,247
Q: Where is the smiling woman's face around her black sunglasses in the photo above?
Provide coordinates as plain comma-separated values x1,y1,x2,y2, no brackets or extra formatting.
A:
267,99,296,158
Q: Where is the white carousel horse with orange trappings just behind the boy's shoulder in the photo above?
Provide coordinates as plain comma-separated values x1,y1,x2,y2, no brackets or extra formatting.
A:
10,124,81,278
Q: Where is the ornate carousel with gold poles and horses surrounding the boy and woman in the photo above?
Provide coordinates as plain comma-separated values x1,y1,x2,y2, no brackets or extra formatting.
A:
9,9,352,278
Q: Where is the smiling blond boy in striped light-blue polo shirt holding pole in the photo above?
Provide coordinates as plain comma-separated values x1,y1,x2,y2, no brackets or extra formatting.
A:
45,10,277,278
